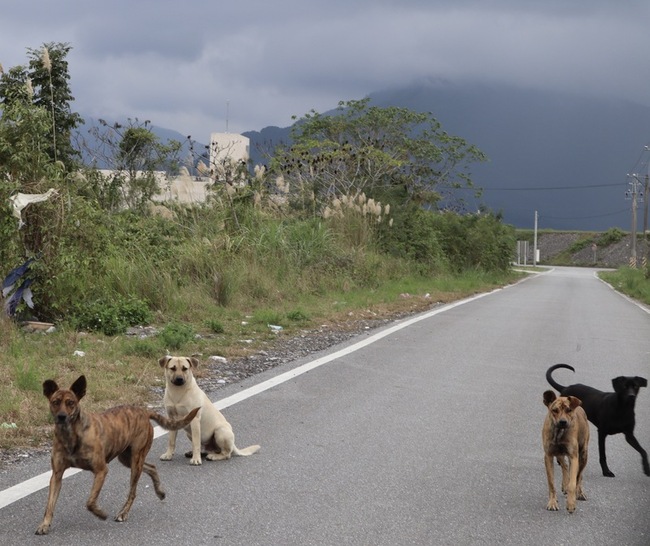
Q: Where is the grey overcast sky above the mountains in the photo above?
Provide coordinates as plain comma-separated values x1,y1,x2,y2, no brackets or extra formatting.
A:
0,0,650,142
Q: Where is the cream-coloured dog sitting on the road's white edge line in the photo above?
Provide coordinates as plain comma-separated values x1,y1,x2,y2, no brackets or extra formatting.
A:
158,355,260,465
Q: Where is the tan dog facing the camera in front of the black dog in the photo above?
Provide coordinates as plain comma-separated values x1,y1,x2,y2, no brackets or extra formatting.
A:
542,391,589,514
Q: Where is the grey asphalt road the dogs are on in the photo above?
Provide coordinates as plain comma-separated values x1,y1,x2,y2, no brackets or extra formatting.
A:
0,268,650,546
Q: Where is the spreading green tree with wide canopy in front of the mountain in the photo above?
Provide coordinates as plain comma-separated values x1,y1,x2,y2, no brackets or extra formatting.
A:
271,98,486,214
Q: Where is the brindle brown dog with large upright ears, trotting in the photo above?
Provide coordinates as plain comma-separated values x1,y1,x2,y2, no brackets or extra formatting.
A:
36,375,199,535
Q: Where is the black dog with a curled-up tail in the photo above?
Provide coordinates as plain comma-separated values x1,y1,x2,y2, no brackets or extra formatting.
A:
546,364,650,478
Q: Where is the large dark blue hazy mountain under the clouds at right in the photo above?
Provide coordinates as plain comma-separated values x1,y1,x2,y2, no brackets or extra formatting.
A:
244,81,650,231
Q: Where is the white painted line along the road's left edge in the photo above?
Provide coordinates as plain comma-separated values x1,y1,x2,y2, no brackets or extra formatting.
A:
0,285,502,509
